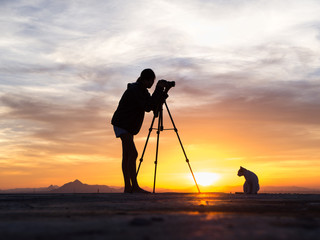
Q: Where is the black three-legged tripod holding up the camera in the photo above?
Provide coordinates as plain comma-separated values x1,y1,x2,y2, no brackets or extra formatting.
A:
136,100,200,193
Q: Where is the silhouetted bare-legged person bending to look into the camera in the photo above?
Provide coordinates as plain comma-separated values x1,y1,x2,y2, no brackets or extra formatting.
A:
111,69,168,193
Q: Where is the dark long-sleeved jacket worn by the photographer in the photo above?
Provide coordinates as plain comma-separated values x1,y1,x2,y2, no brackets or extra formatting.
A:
111,82,168,135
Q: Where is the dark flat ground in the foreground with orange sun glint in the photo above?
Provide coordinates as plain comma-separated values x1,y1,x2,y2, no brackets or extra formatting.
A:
0,193,320,240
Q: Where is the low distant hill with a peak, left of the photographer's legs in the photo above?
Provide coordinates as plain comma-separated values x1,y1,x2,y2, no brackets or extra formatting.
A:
50,179,122,193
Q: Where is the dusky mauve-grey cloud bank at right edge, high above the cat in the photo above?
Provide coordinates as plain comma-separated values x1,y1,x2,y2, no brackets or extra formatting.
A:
215,81,320,125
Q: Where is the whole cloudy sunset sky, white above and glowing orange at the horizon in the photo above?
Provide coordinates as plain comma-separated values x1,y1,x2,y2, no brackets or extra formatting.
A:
0,0,320,191
